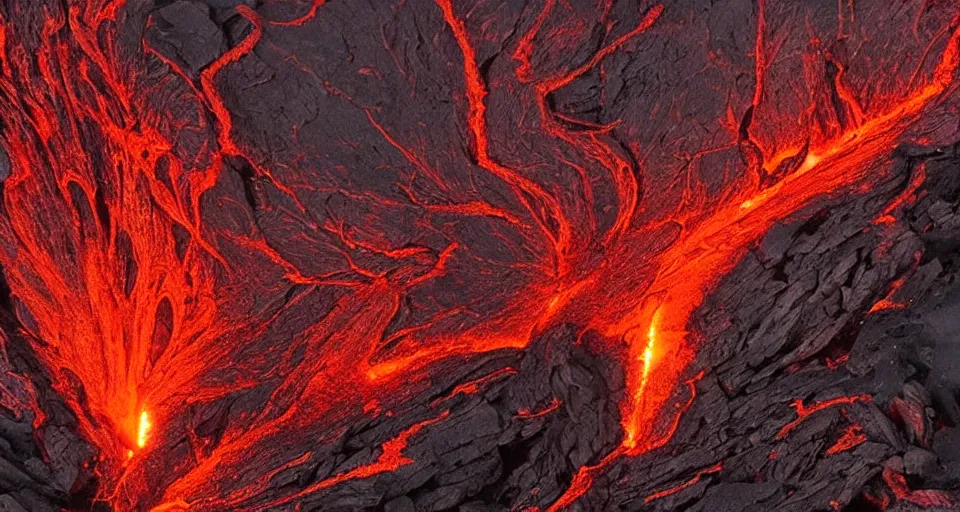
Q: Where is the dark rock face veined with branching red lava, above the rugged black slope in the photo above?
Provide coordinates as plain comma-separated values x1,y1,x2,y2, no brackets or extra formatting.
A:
0,0,960,510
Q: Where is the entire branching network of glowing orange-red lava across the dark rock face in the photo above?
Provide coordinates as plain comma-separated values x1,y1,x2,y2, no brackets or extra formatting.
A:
0,0,960,510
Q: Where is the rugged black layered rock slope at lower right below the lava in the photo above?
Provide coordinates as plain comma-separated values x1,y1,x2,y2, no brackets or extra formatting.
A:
278,146,960,511
